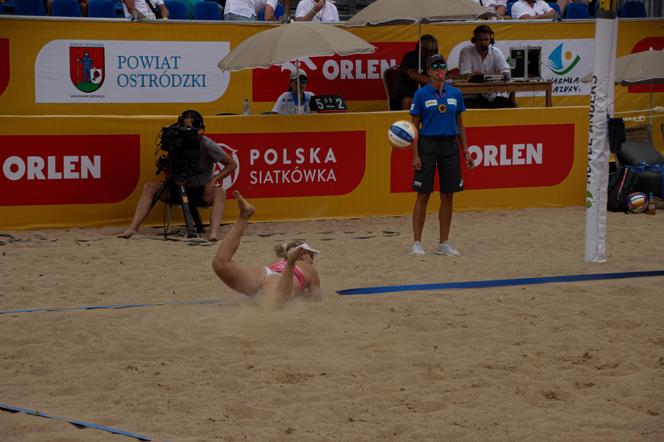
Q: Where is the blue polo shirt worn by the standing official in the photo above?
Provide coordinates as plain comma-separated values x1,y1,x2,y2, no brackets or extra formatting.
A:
410,83,466,137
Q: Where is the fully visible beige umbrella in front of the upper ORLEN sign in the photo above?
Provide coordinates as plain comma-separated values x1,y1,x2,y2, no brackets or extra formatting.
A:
217,22,376,113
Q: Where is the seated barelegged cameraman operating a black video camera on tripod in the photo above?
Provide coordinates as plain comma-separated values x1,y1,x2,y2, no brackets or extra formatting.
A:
119,110,237,241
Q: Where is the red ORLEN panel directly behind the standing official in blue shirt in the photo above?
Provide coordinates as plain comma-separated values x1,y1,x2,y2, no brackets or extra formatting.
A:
390,124,574,193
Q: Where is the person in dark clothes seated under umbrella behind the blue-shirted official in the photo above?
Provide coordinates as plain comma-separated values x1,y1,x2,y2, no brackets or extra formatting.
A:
396,34,438,110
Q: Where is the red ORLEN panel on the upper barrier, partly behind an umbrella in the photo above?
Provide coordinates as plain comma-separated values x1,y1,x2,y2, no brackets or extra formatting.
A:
252,42,415,102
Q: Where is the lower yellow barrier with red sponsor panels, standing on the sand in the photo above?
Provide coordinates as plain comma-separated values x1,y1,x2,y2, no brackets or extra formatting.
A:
0,107,588,229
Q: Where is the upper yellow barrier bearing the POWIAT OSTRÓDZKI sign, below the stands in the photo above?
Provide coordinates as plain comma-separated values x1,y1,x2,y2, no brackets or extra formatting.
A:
0,17,664,115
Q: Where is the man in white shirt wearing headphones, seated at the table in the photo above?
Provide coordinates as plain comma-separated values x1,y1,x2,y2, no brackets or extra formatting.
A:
459,25,514,109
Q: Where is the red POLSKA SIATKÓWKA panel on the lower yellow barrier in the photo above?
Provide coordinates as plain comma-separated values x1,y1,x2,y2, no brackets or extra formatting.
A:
208,131,366,198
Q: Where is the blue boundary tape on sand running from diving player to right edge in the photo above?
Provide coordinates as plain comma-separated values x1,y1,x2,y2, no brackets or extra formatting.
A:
337,270,664,296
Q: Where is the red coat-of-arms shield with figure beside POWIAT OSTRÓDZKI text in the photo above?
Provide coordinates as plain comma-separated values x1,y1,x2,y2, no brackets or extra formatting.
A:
69,46,105,93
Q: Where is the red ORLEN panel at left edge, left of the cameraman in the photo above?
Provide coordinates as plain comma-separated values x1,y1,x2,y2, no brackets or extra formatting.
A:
0,135,140,206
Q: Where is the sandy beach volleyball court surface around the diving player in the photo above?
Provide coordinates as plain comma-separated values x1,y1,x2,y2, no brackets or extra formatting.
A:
0,208,664,441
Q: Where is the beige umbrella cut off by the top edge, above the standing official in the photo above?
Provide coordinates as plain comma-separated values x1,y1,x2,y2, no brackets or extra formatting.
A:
345,0,489,72
